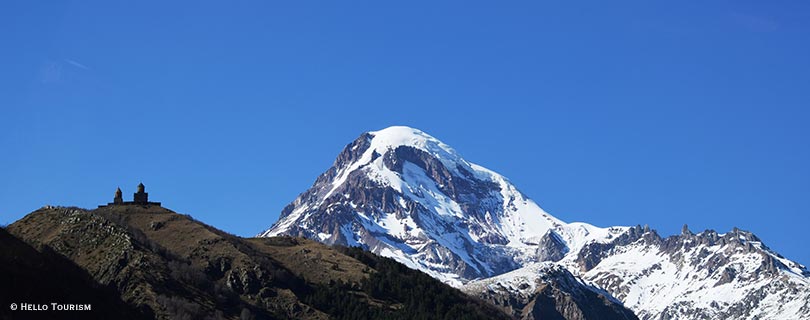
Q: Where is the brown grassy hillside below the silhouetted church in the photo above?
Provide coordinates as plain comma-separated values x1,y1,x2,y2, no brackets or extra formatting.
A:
8,205,508,319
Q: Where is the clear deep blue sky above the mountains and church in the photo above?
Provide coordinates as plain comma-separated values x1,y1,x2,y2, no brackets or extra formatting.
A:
0,1,810,264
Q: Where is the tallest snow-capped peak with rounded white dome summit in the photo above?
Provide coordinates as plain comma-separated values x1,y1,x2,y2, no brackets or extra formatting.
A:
261,127,627,286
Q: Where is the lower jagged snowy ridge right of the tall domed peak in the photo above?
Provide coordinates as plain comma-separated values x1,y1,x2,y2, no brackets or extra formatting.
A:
568,226,810,319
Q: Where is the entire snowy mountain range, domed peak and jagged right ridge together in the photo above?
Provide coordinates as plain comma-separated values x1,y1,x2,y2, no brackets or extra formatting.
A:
260,127,810,319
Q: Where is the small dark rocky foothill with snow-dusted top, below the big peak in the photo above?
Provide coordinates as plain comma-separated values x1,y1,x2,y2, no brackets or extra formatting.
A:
462,263,638,320
